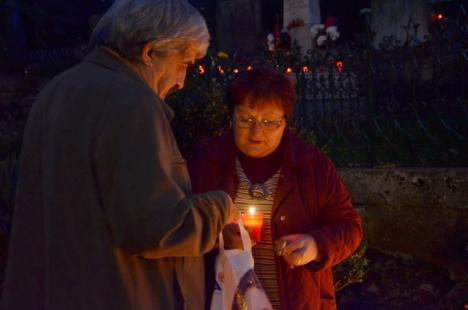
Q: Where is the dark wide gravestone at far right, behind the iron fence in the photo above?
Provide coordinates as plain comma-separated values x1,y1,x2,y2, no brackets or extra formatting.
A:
371,0,429,49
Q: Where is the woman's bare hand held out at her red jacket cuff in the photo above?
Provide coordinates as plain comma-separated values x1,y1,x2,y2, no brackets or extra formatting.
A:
275,234,318,267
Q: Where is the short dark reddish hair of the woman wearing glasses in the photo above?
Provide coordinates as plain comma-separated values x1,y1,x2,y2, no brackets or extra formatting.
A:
226,67,296,119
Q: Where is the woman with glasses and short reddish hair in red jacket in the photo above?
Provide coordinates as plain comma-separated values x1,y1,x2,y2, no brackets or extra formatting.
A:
189,68,362,310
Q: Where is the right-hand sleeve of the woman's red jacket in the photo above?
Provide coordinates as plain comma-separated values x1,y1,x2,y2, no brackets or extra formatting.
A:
308,156,362,270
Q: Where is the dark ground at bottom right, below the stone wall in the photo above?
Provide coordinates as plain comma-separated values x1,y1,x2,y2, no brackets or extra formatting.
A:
337,248,468,310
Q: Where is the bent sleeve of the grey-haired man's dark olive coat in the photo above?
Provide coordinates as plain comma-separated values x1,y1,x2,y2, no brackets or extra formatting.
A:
95,83,231,259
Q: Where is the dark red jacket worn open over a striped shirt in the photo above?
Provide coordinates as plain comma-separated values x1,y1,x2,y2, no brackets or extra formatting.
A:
189,130,362,310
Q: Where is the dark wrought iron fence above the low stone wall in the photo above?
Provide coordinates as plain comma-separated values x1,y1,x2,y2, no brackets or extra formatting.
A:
296,4,468,165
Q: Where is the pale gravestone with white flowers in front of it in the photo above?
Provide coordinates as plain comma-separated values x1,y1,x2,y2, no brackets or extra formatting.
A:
283,0,320,52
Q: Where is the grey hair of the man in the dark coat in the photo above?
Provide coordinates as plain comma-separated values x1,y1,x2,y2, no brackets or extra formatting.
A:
90,0,210,60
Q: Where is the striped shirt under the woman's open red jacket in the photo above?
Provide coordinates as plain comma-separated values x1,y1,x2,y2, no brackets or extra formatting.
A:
234,158,281,310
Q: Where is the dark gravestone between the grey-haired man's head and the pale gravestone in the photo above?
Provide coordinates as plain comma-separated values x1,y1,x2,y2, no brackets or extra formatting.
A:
216,0,266,56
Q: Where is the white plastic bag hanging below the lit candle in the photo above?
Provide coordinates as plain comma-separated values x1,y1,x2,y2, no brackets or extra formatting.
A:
210,221,273,310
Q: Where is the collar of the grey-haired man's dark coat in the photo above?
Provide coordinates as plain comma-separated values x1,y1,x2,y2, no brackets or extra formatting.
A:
84,47,174,121
